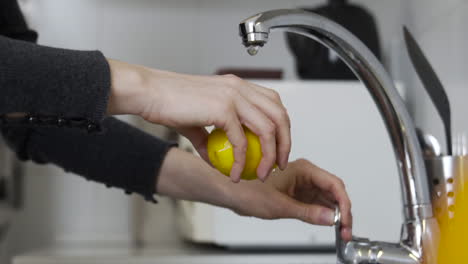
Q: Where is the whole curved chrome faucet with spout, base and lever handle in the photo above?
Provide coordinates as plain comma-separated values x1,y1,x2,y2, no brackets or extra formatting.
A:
239,9,438,264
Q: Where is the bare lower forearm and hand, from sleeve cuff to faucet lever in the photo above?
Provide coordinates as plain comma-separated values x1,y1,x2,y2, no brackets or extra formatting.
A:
157,148,352,241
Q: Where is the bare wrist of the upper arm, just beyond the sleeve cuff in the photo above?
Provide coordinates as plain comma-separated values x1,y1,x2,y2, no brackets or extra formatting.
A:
107,59,146,115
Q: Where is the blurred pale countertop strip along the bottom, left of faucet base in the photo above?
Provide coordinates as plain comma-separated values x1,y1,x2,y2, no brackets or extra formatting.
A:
13,241,336,264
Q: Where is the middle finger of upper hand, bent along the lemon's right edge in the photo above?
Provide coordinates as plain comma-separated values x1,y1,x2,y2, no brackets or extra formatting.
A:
236,98,276,181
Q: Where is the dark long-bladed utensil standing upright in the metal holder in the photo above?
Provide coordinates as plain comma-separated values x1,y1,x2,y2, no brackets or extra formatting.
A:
403,27,452,155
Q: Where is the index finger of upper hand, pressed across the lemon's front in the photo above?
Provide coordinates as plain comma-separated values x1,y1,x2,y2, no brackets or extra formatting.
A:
222,114,247,182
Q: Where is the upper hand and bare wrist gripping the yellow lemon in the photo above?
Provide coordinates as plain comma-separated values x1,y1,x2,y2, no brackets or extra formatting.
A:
108,60,291,182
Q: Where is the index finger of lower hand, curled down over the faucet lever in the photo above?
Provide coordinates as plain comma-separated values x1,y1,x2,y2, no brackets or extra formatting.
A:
302,162,352,228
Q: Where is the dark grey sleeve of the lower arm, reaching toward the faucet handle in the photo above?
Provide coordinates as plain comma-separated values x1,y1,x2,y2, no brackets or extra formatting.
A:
3,117,174,201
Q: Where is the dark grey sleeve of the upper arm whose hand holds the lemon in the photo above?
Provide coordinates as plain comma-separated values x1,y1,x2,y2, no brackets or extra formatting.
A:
0,36,110,129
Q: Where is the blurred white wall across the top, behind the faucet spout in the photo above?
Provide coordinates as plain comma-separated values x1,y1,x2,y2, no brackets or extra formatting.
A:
24,0,406,78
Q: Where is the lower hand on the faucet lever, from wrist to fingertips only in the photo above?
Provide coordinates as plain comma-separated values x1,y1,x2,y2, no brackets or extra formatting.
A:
232,159,352,241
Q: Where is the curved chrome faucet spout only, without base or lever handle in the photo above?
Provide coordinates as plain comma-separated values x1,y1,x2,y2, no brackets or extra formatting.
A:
239,9,432,220
